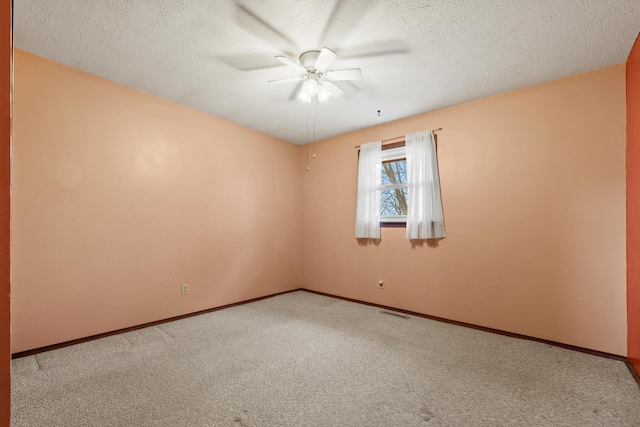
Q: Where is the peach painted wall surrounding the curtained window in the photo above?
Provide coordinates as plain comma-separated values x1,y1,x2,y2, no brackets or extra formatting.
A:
301,64,627,355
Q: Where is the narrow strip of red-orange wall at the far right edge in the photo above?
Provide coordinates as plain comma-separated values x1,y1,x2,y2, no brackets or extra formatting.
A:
627,33,640,372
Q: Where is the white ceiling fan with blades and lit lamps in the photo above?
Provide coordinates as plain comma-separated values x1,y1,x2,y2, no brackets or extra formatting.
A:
269,47,362,102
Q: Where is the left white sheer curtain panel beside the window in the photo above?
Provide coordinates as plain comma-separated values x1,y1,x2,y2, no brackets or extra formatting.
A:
356,141,382,239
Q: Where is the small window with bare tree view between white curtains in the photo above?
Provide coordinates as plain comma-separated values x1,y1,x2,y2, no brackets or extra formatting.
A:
380,142,408,227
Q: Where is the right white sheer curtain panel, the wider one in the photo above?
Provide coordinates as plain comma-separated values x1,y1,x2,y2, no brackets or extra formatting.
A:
405,130,446,239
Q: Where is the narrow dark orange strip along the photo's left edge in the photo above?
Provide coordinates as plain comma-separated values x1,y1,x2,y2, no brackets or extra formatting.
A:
0,1,13,426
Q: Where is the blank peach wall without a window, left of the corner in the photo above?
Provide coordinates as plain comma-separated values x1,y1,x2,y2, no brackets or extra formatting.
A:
12,51,301,352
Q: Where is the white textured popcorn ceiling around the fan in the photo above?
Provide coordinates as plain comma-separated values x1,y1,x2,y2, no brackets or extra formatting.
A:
14,0,640,144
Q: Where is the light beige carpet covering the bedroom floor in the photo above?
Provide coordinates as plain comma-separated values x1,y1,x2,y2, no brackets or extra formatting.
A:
12,291,640,427
